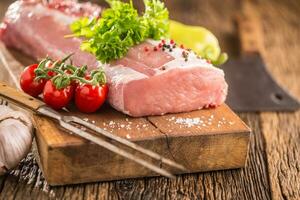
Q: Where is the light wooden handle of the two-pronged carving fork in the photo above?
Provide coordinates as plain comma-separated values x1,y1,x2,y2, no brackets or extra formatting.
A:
0,81,45,112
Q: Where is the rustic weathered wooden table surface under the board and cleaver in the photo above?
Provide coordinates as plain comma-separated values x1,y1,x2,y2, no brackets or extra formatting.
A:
0,0,300,199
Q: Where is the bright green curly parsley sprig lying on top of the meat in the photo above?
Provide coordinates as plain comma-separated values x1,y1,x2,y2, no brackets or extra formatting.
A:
71,0,169,63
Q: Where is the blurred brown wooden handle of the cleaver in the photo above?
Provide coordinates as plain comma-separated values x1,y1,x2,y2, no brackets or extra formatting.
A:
237,0,263,54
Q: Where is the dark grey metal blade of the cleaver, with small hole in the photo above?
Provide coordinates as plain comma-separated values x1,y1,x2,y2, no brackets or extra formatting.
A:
222,53,300,112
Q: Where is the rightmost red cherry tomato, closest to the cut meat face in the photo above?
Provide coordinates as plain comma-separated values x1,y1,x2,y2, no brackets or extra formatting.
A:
75,84,108,113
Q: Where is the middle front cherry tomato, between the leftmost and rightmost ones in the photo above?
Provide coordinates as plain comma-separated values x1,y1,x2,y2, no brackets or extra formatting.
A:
43,80,74,110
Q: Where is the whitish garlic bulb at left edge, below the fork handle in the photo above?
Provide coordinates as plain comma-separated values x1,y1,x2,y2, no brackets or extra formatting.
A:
0,105,33,175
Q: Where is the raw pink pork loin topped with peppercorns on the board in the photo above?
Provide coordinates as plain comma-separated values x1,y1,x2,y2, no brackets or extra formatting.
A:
0,0,227,117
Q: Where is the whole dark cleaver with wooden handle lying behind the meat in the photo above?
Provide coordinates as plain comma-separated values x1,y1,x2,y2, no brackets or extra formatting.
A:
222,1,300,112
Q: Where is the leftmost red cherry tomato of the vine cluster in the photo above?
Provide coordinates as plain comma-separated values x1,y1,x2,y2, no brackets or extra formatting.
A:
20,64,46,97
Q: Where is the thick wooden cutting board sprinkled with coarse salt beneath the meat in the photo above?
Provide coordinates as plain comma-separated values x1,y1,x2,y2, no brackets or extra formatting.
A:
0,44,250,185
